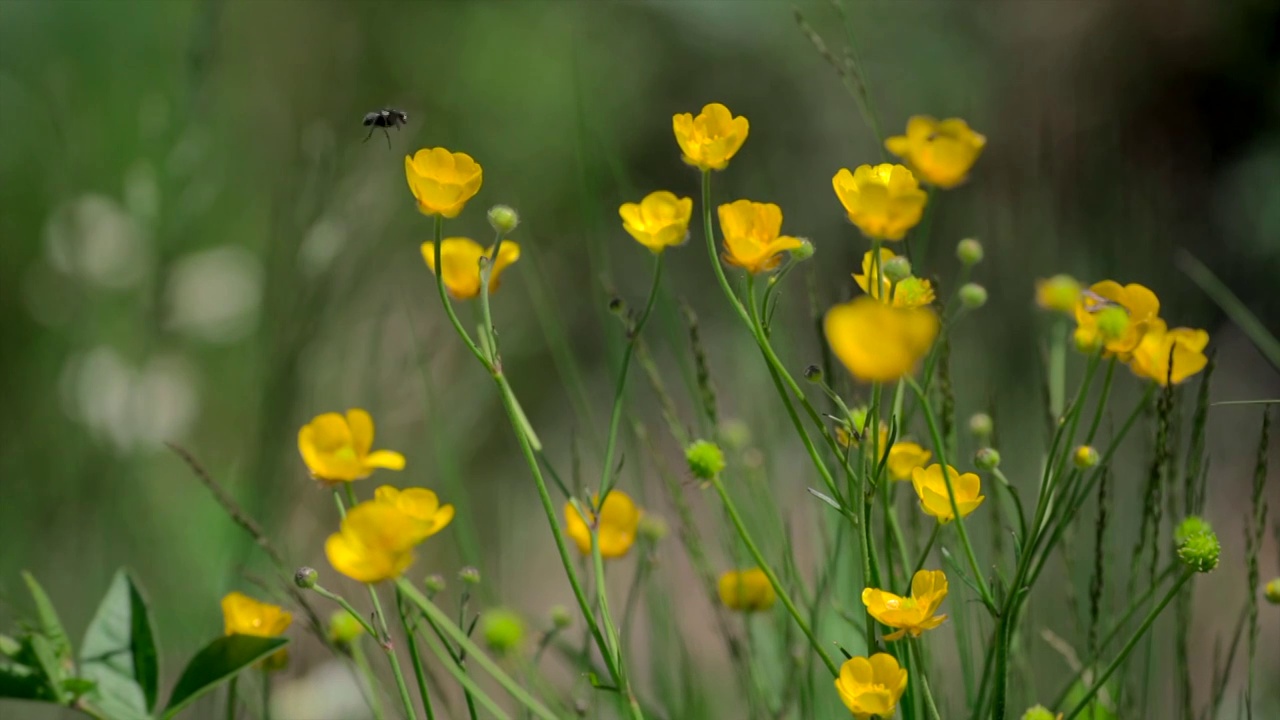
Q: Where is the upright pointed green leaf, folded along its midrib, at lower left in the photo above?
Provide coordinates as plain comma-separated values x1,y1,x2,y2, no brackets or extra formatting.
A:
81,570,160,716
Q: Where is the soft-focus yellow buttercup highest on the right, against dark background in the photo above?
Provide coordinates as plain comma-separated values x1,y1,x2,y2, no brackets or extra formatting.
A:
884,115,987,188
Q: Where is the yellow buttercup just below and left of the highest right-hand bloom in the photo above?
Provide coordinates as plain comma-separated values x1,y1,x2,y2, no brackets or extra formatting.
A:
831,163,928,240
